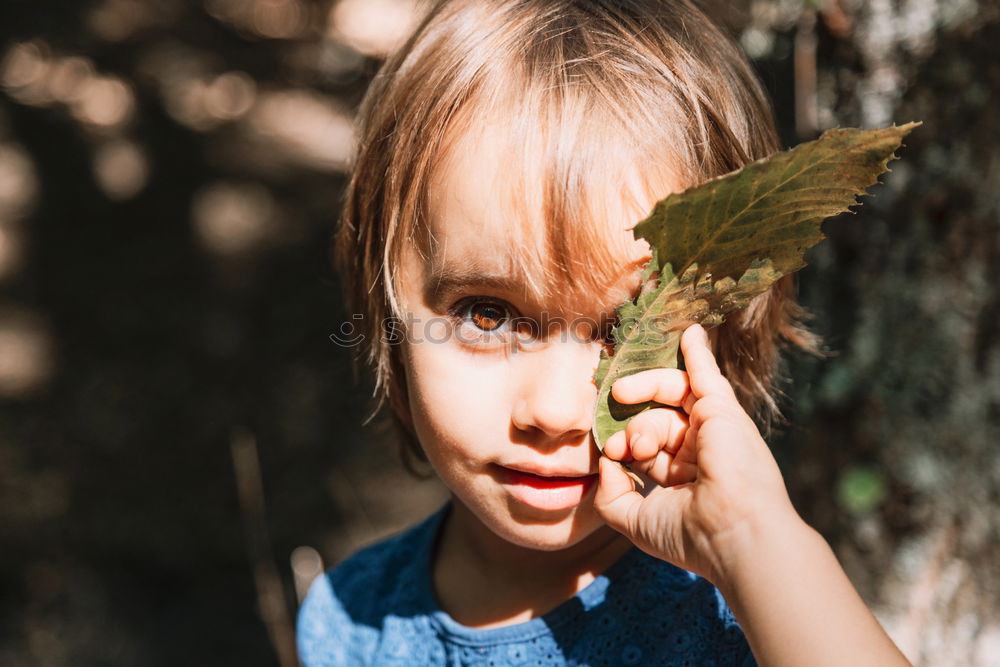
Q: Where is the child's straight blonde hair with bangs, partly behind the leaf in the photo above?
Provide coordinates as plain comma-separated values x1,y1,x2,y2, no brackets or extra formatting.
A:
334,0,816,472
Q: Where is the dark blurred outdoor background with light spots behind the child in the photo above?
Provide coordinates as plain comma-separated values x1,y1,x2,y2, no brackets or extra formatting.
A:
0,0,1000,666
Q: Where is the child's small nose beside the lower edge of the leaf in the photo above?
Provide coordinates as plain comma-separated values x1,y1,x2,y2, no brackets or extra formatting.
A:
511,337,601,439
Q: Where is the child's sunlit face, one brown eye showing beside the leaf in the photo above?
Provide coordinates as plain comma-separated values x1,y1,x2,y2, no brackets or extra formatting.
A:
399,121,649,550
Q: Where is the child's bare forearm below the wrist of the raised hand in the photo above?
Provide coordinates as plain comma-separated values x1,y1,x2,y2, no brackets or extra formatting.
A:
719,515,910,667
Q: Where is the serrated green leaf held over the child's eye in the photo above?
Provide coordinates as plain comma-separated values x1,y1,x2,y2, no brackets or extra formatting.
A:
594,123,920,450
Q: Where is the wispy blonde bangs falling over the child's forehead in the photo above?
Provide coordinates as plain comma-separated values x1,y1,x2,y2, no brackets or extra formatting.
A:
417,39,682,314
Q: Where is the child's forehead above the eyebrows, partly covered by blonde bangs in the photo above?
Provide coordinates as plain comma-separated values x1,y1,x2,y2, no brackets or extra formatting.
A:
423,112,671,308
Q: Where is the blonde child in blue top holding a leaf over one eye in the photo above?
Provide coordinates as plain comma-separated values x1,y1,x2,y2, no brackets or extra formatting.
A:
298,0,907,665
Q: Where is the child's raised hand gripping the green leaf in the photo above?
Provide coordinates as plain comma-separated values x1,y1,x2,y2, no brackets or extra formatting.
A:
594,325,800,585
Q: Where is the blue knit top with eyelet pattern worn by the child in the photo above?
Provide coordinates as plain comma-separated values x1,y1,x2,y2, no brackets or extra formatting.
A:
298,503,756,667
